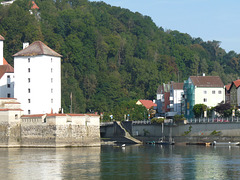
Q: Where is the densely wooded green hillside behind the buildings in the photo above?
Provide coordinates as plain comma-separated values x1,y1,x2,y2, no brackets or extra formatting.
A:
0,0,240,118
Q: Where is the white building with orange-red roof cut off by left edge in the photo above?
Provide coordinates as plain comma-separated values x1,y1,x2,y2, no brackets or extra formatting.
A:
0,35,14,98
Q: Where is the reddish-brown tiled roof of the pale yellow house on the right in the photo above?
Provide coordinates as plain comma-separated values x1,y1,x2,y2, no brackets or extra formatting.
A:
190,76,224,87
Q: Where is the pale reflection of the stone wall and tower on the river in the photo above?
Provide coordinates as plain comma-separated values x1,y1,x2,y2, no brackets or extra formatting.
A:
0,147,101,179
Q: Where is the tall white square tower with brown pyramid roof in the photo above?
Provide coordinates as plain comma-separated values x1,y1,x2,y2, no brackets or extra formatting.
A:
13,41,61,114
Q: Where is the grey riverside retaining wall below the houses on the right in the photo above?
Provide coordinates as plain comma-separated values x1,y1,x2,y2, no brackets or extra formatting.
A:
101,122,240,142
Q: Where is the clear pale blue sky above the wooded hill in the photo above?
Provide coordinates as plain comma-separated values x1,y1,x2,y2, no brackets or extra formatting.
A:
90,0,240,53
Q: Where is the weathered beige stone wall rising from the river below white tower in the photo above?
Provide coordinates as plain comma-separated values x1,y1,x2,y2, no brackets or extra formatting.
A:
0,123,100,147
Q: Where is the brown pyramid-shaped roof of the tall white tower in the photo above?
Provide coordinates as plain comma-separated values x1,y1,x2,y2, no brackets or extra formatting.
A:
13,41,62,57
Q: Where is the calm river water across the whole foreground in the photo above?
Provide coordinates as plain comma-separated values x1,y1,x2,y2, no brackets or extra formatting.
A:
0,145,240,180
